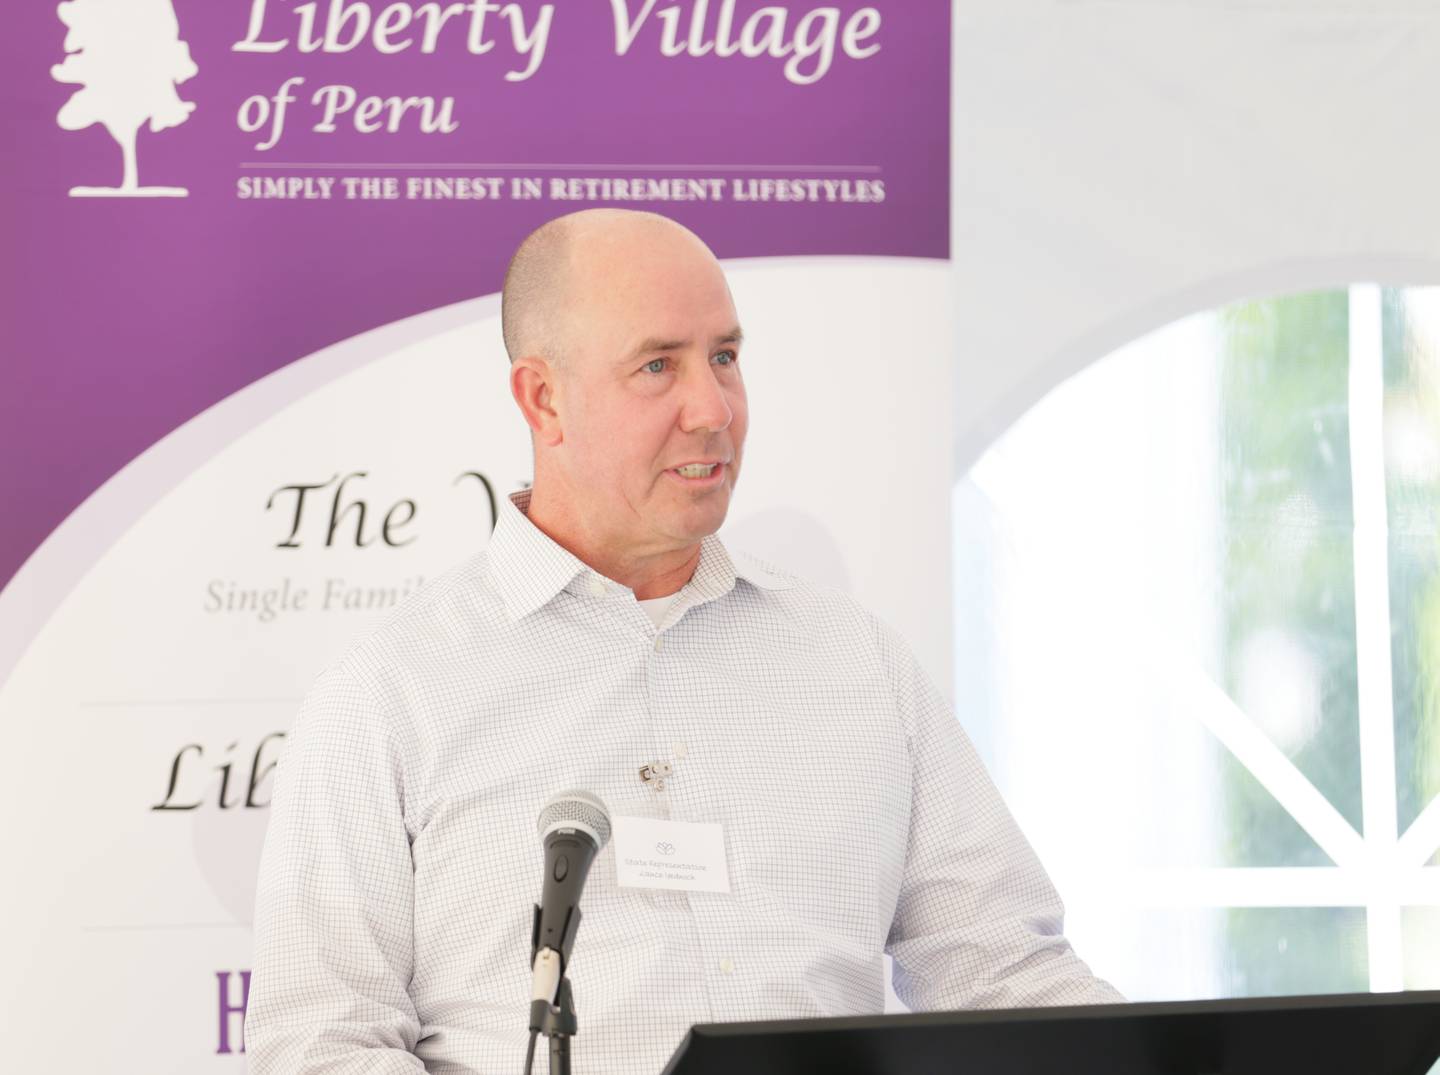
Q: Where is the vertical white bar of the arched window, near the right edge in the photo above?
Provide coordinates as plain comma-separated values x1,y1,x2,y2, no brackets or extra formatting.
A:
1349,284,1404,990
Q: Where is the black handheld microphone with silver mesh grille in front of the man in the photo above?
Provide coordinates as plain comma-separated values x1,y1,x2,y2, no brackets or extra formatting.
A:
530,791,611,1006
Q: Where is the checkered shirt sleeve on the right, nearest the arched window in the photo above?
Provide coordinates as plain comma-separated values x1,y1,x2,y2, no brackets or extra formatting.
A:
880,626,1125,1010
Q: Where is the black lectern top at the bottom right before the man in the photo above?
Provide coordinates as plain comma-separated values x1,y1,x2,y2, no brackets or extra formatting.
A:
664,992,1440,1075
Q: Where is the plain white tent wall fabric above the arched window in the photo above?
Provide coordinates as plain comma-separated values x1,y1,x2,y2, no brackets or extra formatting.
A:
953,0,1440,473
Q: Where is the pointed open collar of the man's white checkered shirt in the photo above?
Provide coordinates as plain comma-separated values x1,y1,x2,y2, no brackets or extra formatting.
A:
487,489,793,620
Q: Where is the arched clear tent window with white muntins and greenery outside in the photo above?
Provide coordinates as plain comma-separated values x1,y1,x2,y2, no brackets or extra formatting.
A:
955,285,1440,999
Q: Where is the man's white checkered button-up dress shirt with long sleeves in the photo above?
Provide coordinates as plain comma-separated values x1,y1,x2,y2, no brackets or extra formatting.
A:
246,492,1119,1075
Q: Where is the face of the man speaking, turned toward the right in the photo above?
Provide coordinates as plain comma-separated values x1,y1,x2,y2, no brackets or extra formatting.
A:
557,232,749,555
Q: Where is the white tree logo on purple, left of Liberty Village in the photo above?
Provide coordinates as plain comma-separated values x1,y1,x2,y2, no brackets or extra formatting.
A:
50,0,199,197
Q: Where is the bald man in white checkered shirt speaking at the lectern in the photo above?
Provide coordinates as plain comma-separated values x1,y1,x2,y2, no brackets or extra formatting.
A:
246,210,1120,1075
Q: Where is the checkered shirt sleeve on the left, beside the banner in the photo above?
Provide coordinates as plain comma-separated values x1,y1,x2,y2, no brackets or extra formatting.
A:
245,665,423,1075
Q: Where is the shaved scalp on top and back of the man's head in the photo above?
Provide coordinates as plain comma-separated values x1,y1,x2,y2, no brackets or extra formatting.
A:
500,209,714,368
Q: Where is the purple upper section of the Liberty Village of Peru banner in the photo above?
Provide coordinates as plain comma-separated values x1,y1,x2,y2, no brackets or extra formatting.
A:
0,0,949,584
